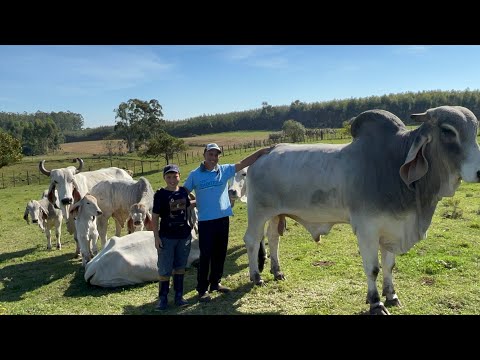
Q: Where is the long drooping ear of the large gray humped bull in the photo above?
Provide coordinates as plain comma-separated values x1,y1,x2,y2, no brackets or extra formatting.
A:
400,135,431,190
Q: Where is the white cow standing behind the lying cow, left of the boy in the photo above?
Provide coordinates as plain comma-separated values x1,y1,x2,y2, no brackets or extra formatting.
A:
90,177,154,247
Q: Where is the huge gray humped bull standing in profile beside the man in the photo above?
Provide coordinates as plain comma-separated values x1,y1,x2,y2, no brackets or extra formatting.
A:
244,106,480,314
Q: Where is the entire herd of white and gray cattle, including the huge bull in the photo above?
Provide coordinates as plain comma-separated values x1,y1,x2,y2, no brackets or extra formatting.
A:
24,106,480,314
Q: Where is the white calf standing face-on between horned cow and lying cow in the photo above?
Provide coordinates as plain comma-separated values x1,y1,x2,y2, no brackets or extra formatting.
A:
70,194,102,266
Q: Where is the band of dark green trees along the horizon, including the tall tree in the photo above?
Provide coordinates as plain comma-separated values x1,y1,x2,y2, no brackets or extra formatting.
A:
0,89,480,169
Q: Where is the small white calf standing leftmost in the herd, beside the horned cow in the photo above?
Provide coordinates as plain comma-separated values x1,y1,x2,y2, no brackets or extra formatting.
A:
23,190,63,250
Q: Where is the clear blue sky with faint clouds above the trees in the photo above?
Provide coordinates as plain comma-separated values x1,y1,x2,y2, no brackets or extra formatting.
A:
0,45,480,128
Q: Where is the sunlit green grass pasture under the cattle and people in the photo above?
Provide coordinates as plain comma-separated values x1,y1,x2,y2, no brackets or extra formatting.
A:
0,139,480,315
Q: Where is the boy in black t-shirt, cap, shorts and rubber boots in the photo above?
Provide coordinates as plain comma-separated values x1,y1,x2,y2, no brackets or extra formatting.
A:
152,164,194,310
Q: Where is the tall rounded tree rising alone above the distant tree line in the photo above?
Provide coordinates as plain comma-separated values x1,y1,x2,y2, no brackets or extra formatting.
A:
113,99,165,152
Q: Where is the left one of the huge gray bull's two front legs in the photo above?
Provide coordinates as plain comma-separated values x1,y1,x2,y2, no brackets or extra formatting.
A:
357,230,390,315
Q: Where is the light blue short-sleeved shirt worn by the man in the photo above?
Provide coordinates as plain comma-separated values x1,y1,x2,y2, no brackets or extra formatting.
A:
183,163,235,221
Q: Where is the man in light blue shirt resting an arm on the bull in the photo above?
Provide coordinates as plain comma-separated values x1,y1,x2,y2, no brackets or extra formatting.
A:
183,143,272,302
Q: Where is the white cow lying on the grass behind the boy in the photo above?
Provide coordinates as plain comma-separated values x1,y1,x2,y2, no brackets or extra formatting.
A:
85,231,200,287
